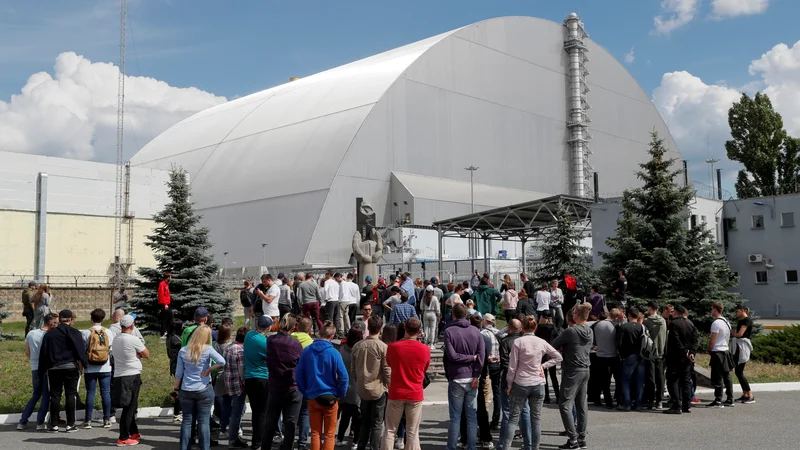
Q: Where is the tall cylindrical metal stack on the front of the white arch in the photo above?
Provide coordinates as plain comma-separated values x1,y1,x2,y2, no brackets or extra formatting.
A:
564,13,594,197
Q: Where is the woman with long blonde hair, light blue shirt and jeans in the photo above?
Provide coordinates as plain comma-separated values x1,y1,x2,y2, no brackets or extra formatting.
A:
175,325,225,450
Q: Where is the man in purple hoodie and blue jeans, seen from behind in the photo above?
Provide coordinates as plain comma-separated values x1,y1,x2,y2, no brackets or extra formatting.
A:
444,303,486,450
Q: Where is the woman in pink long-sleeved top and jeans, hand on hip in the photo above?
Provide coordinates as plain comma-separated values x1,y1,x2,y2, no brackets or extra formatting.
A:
503,316,562,449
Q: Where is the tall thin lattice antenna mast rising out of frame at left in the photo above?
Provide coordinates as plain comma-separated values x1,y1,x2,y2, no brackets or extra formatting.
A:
114,0,128,290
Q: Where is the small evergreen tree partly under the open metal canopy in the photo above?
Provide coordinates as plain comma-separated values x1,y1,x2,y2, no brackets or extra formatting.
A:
528,204,594,284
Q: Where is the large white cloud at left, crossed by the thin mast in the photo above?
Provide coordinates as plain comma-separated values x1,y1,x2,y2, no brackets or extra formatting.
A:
0,52,226,162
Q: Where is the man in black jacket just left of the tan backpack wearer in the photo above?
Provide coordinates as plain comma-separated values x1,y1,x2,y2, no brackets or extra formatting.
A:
39,309,89,433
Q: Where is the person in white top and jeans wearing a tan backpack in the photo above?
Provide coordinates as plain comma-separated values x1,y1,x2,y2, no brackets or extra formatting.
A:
81,308,114,430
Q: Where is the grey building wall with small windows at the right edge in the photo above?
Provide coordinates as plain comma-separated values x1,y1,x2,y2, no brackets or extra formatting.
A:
723,194,800,319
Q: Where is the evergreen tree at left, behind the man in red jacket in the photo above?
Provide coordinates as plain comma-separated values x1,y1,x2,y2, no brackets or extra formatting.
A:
131,169,232,328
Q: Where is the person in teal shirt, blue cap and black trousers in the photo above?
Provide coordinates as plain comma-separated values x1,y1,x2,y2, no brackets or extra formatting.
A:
244,316,273,448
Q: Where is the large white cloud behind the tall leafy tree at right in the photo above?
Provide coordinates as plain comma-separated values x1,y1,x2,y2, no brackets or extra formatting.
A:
653,41,800,190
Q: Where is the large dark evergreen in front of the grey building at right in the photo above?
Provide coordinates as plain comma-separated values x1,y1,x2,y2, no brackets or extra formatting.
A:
600,132,736,329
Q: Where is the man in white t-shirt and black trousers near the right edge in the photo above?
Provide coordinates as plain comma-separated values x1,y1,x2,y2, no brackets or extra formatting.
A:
707,302,733,408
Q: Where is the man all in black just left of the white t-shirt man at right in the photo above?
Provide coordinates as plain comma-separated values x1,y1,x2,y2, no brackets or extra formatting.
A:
664,305,698,414
